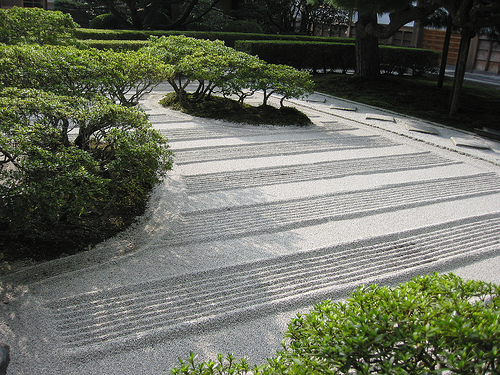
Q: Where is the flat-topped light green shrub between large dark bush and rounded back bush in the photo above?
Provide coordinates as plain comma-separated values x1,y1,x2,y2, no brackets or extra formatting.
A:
0,45,172,106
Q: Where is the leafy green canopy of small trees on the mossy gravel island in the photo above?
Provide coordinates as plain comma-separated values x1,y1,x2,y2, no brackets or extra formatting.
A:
144,36,312,108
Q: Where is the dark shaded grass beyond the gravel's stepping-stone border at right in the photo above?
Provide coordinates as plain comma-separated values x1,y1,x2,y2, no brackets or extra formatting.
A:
313,73,500,131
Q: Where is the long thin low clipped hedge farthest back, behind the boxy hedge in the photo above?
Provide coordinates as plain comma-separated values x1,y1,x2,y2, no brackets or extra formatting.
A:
75,29,352,47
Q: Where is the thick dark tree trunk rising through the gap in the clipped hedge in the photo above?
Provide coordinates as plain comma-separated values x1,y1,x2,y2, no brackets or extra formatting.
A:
356,11,380,77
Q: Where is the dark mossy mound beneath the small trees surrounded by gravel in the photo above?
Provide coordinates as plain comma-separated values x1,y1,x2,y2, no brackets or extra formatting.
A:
160,93,311,126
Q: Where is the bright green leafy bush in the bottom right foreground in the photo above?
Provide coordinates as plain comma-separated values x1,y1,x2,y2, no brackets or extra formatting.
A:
172,274,500,375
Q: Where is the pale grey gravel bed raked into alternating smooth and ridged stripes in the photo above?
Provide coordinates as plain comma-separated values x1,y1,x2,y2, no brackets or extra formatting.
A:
0,86,500,375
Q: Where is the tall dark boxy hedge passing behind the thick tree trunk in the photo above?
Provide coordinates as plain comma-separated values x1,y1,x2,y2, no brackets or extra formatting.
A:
235,39,440,75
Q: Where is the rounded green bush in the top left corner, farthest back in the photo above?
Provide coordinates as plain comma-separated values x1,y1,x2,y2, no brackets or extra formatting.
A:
0,7,78,44
